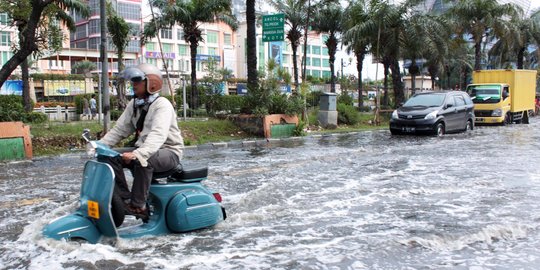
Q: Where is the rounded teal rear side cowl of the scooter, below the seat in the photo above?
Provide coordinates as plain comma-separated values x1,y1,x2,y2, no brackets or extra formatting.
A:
166,189,223,232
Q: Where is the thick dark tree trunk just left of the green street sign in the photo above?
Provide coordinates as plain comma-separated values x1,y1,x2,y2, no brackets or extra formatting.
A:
246,0,259,89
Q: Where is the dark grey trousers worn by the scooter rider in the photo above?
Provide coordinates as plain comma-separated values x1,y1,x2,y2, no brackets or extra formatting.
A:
101,149,180,207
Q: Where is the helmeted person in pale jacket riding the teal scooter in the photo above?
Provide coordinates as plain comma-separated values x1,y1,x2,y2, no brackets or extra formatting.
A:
96,64,184,217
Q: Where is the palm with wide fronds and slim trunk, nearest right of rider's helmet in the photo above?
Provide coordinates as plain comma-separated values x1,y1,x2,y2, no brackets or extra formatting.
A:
143,0,237,109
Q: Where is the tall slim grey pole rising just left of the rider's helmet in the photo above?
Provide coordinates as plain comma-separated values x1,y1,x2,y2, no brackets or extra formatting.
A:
99,0,111,133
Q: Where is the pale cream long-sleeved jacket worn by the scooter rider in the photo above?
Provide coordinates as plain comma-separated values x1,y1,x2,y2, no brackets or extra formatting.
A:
100,97,184,167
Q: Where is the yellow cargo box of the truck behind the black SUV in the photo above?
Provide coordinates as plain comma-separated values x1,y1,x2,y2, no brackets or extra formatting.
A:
472,69,536,112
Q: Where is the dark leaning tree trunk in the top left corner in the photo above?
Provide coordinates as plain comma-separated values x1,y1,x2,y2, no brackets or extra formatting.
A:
0,0,43,87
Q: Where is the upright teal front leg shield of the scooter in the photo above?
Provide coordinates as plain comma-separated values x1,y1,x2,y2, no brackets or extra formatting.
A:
79,160,118,237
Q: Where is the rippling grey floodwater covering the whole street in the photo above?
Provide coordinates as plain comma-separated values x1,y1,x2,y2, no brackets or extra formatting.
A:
0,121,540,269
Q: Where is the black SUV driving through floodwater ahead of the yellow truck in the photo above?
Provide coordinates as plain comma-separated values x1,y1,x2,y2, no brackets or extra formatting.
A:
390,91,474,136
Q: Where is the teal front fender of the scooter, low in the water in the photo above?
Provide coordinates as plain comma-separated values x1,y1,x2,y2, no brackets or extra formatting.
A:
43,213,101,244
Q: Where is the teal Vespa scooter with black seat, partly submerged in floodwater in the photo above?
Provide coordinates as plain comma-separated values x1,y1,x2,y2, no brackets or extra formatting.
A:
43,130,226,243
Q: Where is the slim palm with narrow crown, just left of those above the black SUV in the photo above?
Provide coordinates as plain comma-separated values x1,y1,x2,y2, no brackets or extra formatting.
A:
343,0,377,108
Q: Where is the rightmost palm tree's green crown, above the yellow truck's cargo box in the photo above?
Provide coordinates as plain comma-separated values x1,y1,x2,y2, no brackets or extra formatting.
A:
489,8,540,69
